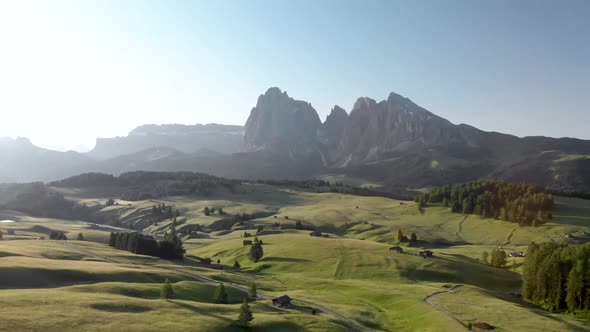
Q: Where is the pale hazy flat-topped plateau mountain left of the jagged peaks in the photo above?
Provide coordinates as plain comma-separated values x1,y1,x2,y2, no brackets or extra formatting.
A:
88,124,244,160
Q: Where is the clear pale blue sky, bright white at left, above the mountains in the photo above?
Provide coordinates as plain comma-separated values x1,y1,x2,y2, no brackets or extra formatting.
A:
0,0,590,148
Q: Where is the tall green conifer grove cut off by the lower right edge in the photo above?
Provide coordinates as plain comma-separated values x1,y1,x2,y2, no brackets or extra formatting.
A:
522,242,590,316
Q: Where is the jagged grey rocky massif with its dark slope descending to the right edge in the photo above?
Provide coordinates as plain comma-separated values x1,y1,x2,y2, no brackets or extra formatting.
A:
245,88,590,191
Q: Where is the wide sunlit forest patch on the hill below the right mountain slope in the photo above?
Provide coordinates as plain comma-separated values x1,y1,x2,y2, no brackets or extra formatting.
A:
415,180,554,226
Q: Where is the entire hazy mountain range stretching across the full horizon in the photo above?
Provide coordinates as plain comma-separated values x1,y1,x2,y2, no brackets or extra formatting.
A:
0,88,590,192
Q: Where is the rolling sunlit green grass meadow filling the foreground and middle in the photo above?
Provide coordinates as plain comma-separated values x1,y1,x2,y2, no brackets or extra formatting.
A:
0,184,590,331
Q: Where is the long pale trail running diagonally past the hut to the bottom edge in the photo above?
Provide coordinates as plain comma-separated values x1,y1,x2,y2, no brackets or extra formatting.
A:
63,240,368,332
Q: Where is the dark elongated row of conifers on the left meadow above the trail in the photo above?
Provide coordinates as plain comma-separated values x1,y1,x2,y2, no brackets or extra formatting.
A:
109,232,185,259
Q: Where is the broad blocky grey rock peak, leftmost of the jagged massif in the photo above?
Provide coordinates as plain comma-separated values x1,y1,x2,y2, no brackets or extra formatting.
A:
244,88,322,155
